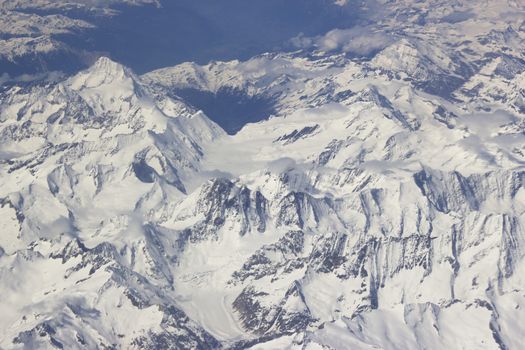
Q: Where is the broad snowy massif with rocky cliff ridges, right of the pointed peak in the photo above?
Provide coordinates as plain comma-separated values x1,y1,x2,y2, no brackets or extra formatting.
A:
146,50,525,349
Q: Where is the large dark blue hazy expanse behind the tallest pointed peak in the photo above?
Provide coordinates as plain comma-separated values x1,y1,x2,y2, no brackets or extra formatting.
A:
65,0,357,73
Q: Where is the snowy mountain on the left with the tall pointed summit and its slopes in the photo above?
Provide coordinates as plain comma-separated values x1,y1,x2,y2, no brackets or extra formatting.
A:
0,58,223,348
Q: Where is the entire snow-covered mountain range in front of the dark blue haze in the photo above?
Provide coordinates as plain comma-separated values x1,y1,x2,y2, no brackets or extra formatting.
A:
0,0,525,350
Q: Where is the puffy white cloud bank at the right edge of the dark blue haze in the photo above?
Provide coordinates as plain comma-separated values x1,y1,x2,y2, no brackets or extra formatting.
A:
292,27,394,56
